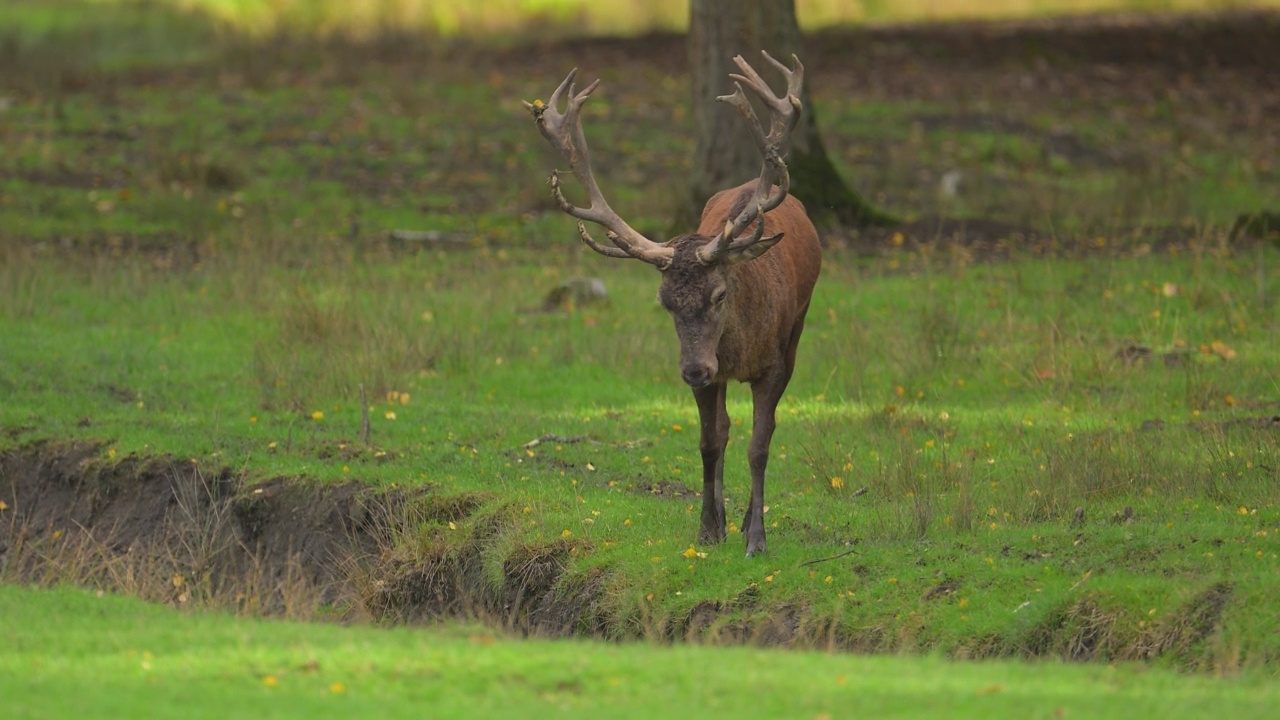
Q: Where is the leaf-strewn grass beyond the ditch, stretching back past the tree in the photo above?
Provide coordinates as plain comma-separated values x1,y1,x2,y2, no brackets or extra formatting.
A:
0,0,1280,669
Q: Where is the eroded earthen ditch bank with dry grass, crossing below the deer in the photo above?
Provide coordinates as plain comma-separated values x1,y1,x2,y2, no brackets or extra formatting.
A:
0,442,1234,667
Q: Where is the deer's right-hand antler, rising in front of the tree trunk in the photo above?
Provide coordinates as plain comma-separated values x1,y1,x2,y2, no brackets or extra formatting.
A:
698,51,804,263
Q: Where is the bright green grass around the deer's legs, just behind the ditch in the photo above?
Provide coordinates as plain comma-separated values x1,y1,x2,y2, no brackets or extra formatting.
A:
0,240,1280,667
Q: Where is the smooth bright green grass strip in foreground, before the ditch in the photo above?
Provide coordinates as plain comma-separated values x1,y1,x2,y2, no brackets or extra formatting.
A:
0,585,1280,719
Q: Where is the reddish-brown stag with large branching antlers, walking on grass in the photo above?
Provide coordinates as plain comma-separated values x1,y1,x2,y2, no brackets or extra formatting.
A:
525,53,822,557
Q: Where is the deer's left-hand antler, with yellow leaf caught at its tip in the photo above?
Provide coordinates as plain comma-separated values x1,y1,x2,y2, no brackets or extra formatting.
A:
525,68,675,268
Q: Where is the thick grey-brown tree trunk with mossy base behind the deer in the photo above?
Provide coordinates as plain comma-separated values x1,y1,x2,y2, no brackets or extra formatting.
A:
677,0,895,227
